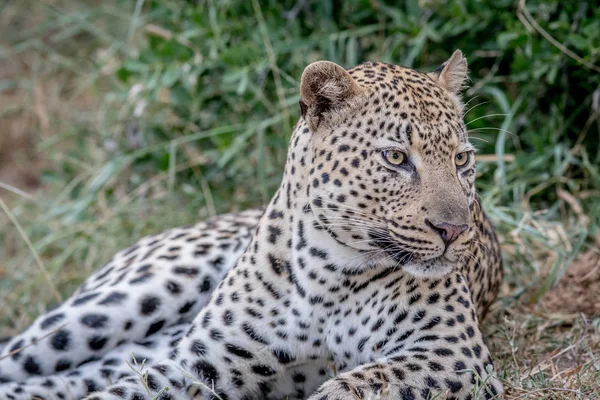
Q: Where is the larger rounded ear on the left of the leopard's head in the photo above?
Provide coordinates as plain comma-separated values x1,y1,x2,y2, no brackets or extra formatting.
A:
300,61,362,132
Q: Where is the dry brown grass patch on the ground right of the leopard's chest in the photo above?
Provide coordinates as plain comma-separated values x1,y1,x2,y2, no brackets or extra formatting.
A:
483,242,600,400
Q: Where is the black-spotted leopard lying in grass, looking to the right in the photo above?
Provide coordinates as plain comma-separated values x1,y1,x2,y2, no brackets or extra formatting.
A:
0,50,503,400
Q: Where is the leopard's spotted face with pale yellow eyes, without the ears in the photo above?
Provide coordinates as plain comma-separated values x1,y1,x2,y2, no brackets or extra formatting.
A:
305,54,475,277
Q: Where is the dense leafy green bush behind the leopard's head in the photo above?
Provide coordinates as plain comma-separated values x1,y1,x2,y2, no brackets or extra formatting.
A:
96,0,600,294
